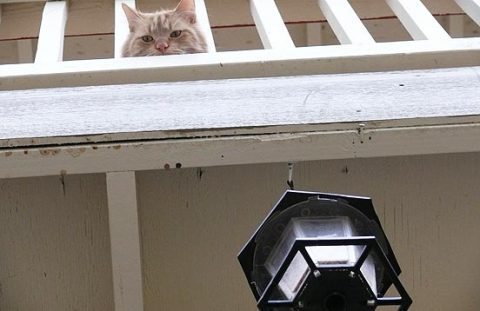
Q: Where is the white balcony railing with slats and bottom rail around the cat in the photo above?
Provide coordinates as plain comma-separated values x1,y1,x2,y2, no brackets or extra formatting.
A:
0,0,480,90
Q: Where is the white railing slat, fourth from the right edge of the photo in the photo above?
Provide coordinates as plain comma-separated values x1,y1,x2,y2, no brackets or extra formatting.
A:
250,0,295,50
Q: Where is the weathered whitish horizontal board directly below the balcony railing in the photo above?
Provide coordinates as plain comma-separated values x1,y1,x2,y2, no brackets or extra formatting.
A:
0,67,480,147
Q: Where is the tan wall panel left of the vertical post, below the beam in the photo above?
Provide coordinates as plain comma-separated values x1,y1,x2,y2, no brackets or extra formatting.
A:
0,174,114,311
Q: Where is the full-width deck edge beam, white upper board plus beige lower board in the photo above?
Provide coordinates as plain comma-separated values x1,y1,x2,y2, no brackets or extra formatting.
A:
0,67,480,180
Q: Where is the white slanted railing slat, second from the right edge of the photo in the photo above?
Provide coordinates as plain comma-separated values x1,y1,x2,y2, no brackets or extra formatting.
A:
386,0,450,40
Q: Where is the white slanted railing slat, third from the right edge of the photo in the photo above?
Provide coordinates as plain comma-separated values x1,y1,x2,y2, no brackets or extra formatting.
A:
318,0,375,44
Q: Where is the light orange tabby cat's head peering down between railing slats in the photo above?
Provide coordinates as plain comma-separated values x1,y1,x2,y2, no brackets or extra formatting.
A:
122,0,207,57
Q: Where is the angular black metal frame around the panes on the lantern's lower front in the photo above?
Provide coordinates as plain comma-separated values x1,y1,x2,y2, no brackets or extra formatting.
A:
257,236,412,311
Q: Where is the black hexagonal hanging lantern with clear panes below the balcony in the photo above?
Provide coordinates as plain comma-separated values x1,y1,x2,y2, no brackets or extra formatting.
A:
238,191,412,311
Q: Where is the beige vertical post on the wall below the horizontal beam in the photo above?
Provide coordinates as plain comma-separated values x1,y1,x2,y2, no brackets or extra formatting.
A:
106,172,143,311
